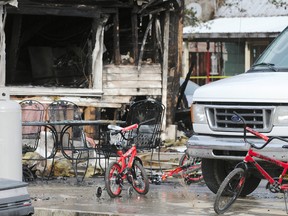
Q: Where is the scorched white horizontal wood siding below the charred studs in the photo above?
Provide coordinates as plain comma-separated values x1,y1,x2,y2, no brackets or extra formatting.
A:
103,64,162,104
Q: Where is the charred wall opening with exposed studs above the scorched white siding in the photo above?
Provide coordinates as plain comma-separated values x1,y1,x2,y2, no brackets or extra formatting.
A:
103,8,162,65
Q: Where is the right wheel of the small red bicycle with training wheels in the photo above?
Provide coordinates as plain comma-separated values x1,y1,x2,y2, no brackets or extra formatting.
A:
132,161,149,195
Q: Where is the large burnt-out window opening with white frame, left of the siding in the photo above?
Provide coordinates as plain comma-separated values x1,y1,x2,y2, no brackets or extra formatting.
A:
5,14,92,88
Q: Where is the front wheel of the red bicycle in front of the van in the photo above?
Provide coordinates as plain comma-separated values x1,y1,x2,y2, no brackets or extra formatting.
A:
214,168,246,214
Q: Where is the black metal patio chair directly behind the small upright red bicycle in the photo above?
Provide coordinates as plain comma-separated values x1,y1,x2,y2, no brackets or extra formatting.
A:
98,99,165,172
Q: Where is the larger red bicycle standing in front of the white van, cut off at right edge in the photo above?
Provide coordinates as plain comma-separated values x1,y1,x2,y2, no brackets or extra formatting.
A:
214,112,288,214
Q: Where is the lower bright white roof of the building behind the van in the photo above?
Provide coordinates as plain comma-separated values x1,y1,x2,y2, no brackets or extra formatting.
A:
183,16,288,41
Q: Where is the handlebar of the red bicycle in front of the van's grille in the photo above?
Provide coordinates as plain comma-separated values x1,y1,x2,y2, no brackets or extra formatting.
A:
232,112,288,149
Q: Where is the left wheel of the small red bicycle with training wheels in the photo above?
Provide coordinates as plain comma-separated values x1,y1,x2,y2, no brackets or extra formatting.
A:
105,162,123,198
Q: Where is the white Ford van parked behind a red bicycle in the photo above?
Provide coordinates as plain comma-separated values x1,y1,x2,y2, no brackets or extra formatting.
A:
187,25,288,195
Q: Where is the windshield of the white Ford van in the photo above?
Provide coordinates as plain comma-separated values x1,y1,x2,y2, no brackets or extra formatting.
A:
249,28,288,72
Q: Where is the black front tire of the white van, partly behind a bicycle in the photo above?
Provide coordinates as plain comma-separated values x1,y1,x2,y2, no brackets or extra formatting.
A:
201,158,261,197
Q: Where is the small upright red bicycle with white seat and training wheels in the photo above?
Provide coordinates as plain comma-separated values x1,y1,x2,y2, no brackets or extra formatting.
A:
105,124,149,198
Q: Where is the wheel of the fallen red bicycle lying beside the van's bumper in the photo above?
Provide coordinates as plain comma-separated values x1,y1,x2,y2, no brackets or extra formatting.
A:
179,151,203,185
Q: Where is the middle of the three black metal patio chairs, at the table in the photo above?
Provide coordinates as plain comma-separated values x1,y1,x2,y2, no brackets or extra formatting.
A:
47,100,91,181
